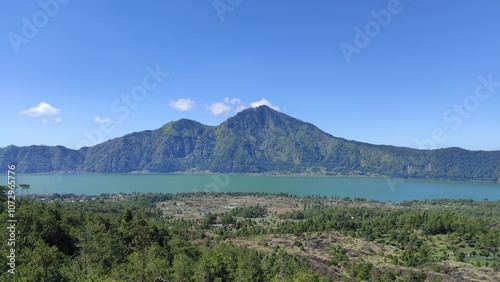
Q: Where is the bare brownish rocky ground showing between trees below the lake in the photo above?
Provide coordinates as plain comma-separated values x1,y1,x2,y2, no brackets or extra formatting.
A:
158,195,500,282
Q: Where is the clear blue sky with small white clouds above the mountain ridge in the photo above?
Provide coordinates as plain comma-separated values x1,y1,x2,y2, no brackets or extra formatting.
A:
0,0,500,150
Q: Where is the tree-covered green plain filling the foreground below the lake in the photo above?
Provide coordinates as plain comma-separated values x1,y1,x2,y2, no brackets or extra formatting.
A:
0,188,500,282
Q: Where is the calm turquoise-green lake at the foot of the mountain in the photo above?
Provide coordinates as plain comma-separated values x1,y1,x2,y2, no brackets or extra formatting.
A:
11,173,500,202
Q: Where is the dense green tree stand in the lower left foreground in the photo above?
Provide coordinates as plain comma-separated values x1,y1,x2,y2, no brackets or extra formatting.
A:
0,194,326,281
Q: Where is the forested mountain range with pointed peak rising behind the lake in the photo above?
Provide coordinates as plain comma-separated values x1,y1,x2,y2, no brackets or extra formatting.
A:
0,106,500,181
